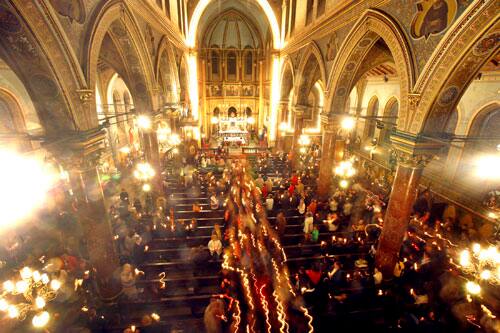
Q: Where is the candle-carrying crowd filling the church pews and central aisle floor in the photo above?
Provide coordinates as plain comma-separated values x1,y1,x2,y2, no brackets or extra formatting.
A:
0,136,499,333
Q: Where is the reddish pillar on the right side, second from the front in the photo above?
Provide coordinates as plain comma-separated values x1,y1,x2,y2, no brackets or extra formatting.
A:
317,115,344,200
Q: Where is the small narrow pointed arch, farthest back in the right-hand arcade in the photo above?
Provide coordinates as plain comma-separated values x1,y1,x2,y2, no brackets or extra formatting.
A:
294,42,326,105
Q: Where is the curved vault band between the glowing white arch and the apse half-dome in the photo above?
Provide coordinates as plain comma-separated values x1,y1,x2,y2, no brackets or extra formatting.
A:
196,0,269,45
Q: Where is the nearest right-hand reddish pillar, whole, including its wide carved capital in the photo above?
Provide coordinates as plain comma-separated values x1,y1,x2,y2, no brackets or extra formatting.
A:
375,133,437,279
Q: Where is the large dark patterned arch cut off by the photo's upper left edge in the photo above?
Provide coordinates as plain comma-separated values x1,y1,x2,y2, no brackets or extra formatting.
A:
0,2,78,138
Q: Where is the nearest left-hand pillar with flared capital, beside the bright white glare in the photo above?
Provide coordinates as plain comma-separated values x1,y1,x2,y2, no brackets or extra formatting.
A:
51,130,121,300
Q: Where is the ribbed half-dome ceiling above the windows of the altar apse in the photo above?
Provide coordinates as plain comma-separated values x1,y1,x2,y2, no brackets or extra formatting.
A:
203,11,261,49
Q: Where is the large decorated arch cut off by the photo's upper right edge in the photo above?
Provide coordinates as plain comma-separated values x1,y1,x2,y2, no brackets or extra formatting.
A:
409,1,500,133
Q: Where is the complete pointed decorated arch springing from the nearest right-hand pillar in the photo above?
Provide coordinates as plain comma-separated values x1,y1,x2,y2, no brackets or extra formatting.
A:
326,9,415,129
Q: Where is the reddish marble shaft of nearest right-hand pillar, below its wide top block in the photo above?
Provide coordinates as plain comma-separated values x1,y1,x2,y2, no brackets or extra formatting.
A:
375,152,428,279
